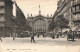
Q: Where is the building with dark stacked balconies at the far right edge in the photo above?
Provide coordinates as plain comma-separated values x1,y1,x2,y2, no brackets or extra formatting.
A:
72,0,80,29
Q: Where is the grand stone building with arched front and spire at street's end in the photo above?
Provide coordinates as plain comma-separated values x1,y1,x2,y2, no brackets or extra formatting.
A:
27,6,52,34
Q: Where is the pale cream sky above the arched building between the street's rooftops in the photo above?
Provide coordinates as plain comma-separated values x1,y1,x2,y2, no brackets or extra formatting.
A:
13,0,58,18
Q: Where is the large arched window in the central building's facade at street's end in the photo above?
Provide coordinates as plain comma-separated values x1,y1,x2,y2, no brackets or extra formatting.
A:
33,18,47,32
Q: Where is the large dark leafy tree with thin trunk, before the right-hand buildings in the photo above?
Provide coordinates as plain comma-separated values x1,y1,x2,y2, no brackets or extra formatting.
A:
56,15,69,34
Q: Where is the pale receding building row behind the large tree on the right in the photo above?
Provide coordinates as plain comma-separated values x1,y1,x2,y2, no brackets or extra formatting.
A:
53,0,72,33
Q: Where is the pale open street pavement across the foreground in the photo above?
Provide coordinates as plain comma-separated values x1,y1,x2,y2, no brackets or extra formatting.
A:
0,37,80,52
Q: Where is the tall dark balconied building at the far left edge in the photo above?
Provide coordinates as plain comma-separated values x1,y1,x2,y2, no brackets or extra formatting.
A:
0,0,13,36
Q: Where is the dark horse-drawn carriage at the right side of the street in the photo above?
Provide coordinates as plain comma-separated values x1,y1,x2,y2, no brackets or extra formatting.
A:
67,28,80,40
